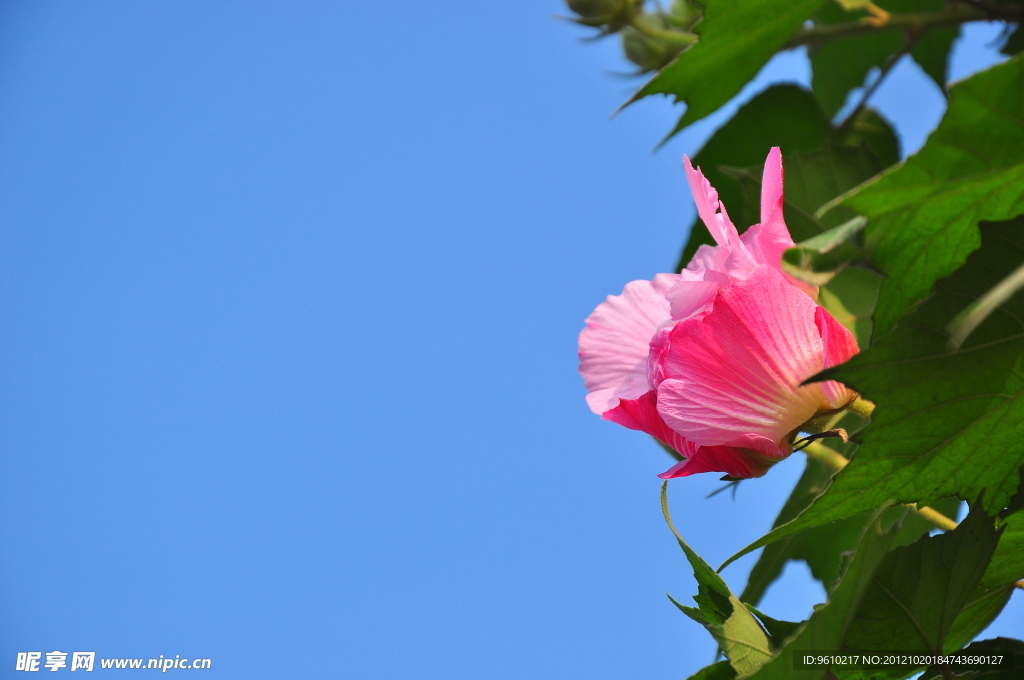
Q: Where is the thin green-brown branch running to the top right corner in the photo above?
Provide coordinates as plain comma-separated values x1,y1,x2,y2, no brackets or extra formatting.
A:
785,5,999,48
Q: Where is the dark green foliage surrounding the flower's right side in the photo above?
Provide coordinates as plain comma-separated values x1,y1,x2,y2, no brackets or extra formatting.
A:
577,0,1024,667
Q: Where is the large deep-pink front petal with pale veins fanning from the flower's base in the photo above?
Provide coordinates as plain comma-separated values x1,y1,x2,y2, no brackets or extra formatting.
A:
657,266,823,456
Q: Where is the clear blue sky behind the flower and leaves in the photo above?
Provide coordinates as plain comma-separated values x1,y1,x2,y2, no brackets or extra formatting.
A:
0,0,1024,680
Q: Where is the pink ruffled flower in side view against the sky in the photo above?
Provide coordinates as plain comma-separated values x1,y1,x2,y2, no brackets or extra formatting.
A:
580,148,857,478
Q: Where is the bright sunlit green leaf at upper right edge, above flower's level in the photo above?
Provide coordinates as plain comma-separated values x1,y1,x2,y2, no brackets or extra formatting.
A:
845,56,1024,334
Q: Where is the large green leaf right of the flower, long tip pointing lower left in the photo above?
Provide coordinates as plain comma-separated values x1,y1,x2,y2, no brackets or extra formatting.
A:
716,219,1024,561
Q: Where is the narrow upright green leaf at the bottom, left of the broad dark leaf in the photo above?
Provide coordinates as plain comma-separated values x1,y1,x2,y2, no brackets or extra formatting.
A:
737,516,894,680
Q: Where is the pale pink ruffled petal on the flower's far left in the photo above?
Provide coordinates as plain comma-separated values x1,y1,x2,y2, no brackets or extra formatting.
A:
580,273,679,415
